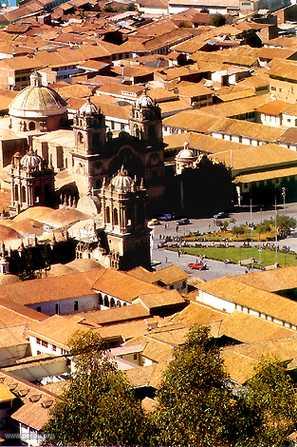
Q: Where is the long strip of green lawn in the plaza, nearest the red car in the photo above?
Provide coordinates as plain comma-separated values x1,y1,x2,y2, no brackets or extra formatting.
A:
177,247,297,267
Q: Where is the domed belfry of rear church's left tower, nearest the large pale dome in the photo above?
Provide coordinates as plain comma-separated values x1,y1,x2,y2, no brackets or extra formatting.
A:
73,98,106,155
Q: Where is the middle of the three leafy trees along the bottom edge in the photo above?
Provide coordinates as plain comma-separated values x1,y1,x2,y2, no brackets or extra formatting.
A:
153,327,232,447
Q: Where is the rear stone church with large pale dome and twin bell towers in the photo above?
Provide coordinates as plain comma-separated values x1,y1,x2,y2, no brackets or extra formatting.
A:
4,72,165,211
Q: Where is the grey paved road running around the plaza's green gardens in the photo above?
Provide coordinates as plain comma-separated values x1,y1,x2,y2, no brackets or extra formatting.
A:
152,203,297,280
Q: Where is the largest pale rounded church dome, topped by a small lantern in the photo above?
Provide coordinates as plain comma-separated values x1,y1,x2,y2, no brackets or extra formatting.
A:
9,73,67,118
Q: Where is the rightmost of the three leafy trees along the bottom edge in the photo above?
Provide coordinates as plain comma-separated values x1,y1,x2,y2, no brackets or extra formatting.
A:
233,359,297,447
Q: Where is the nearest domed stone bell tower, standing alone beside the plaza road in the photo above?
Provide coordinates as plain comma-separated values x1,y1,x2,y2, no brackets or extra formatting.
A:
100,166,151,270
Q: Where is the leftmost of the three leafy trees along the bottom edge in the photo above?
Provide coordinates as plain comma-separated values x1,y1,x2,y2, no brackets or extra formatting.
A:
45,331,144,446
